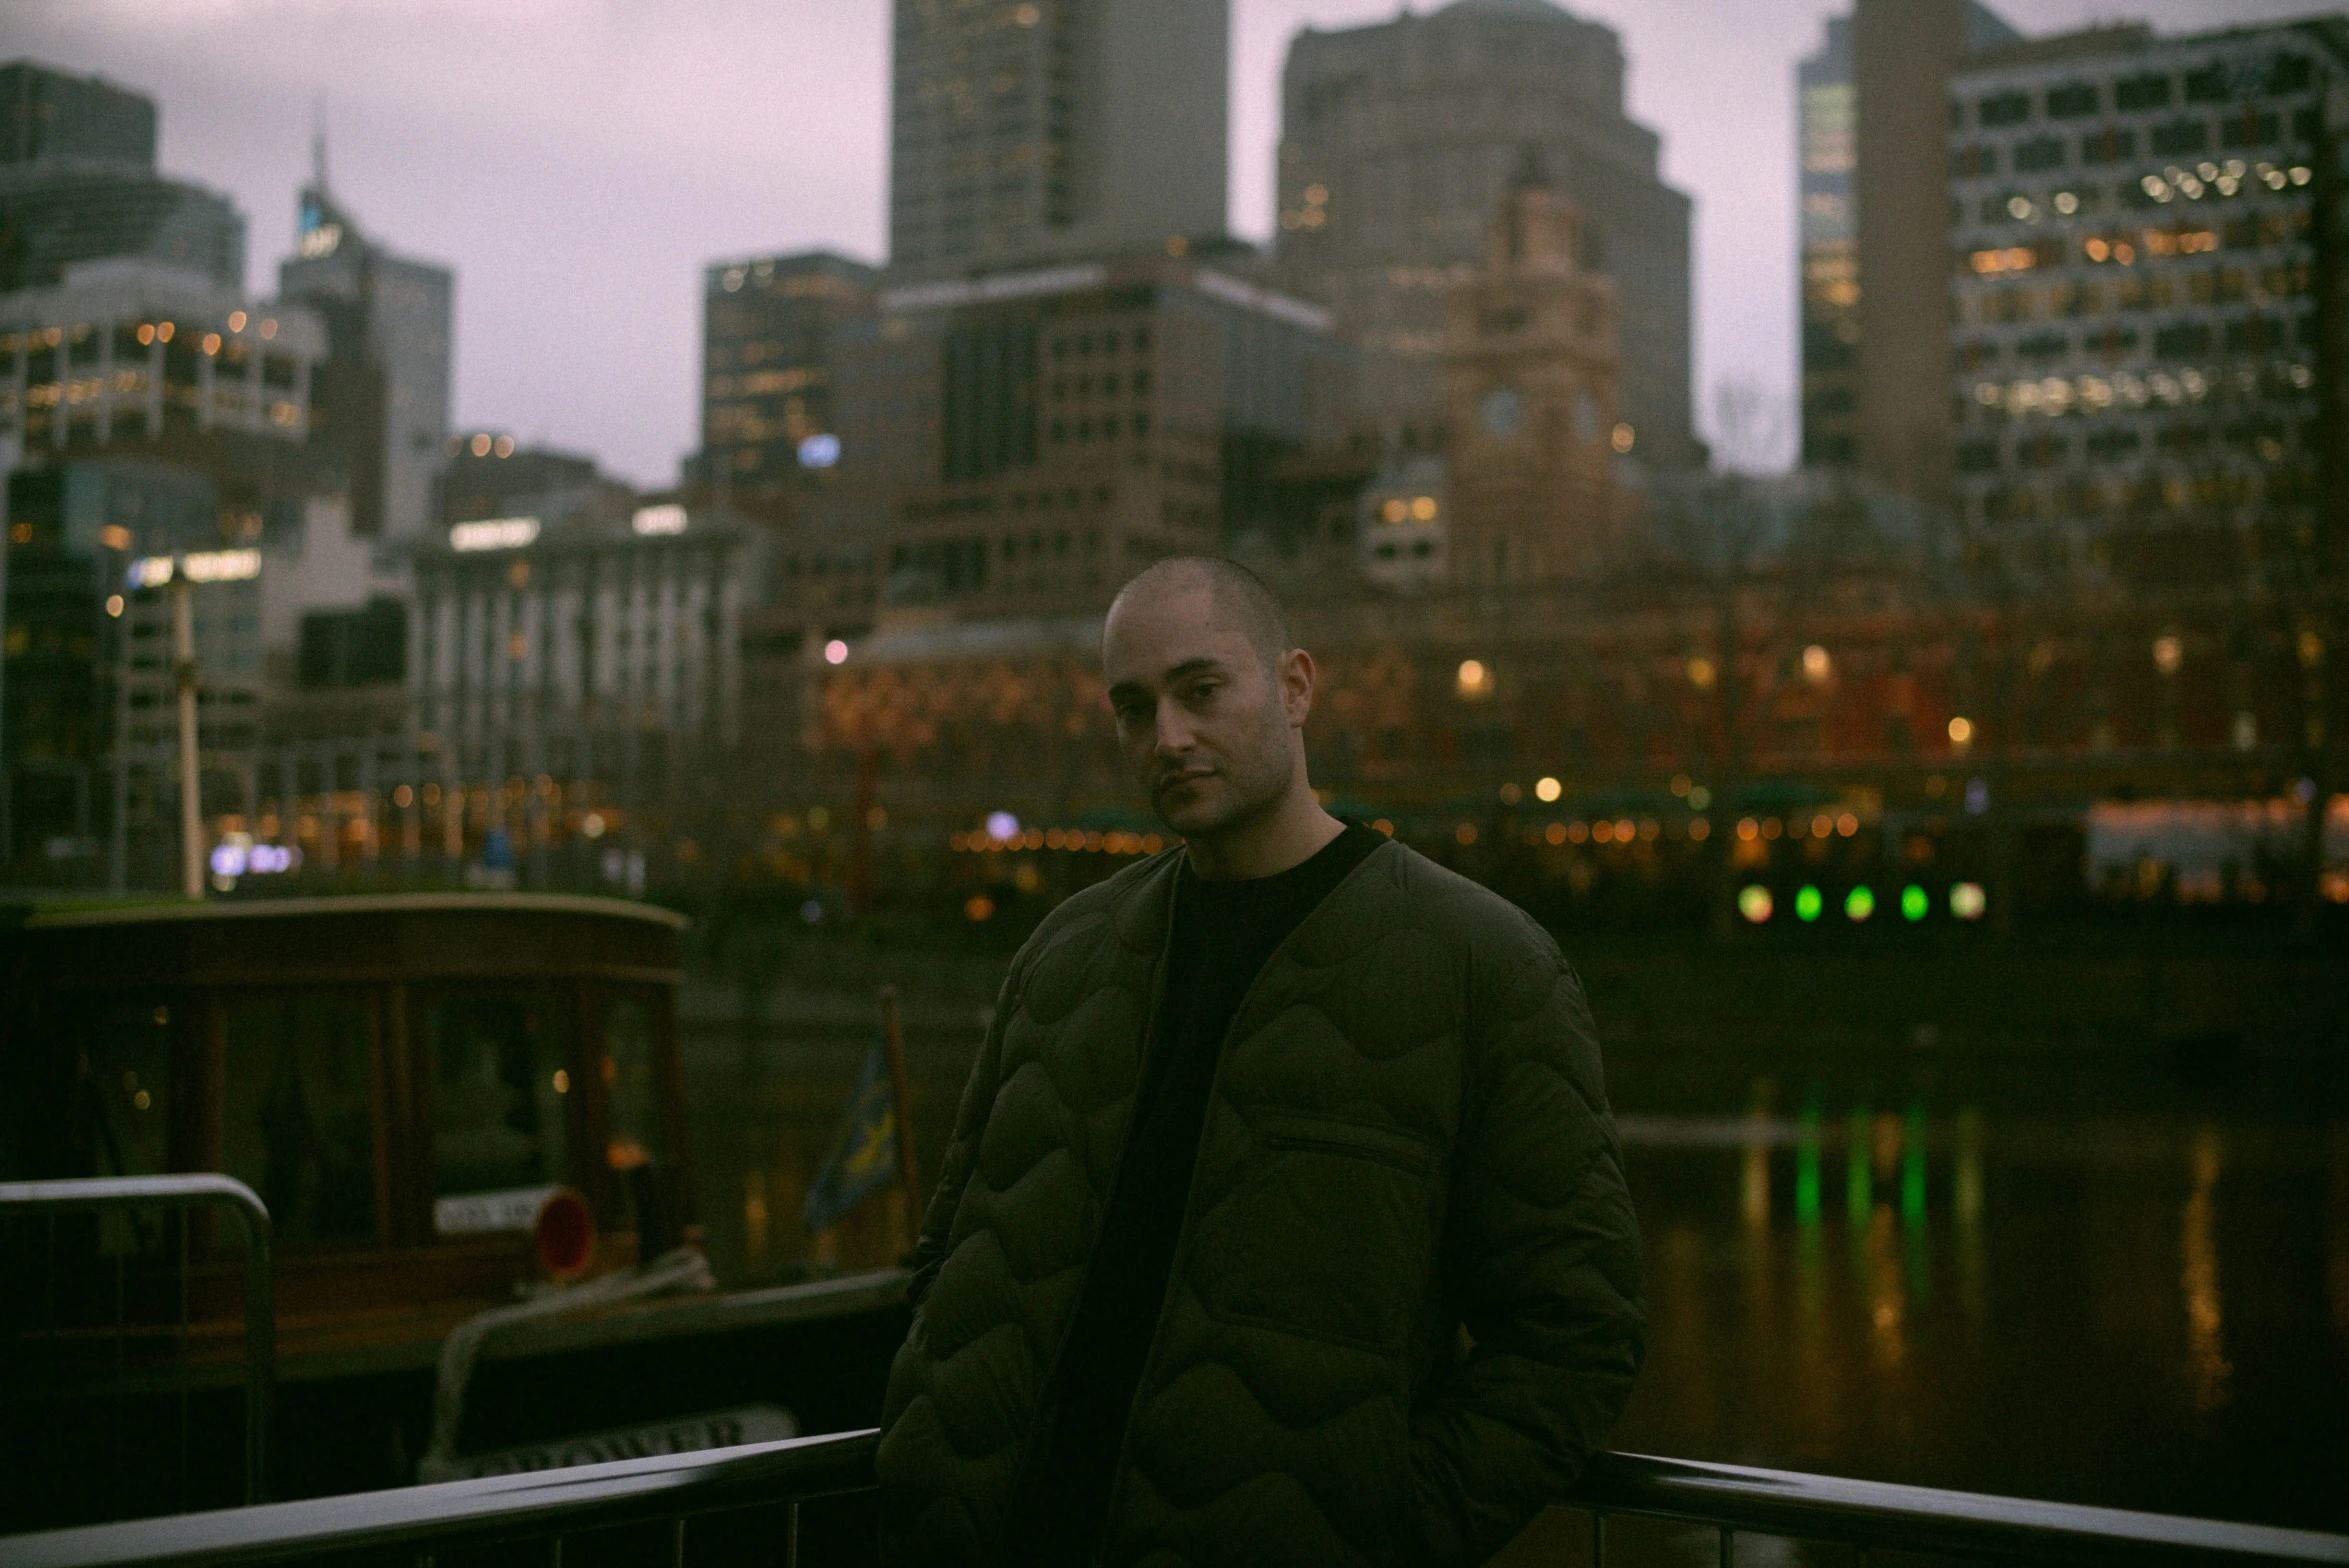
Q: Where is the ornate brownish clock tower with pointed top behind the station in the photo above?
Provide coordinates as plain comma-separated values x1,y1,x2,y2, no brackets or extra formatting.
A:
1442,150,1635,587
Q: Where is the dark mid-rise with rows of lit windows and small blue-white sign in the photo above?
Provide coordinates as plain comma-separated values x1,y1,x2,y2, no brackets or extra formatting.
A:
698,251,881,514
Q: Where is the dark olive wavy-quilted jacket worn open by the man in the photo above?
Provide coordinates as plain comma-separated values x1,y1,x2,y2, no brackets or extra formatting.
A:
879,843,1644,1568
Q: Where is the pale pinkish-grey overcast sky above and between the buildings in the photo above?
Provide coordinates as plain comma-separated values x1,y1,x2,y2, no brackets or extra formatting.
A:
0,0,2314,484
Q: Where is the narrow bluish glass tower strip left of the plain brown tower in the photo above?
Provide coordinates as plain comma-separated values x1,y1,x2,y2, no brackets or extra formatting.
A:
1795,16,1860,467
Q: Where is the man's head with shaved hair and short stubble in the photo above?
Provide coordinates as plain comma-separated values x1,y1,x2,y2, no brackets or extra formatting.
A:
1102,556,1313,838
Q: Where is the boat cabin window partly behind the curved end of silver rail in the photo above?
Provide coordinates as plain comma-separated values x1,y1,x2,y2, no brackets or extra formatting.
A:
221,993,376,1246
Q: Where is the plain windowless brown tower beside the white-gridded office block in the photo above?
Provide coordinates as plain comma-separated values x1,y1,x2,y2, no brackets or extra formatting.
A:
1841,0,2020,502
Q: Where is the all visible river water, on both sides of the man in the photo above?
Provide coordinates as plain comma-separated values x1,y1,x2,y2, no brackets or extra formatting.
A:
686,998,2349,1530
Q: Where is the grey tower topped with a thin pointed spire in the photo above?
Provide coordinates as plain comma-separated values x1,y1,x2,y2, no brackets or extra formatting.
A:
277,146,456,540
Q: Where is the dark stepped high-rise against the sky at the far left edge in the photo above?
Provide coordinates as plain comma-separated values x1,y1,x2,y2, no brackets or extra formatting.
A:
0,61,244,293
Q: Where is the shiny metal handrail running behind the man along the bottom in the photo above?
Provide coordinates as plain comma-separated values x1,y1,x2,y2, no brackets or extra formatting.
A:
0,1432,2349,1568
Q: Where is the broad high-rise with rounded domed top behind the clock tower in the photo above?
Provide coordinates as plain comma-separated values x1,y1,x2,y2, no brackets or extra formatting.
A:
1278,0,1698,467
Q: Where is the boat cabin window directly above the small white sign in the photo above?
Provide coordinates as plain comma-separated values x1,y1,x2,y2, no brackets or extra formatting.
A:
425,991,571,1235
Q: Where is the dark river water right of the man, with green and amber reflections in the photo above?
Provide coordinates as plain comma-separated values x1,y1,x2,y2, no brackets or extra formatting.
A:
1616,1073,2349,1528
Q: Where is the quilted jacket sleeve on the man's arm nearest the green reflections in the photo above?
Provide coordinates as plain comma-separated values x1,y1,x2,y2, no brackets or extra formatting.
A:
1412,937,1647,1566
